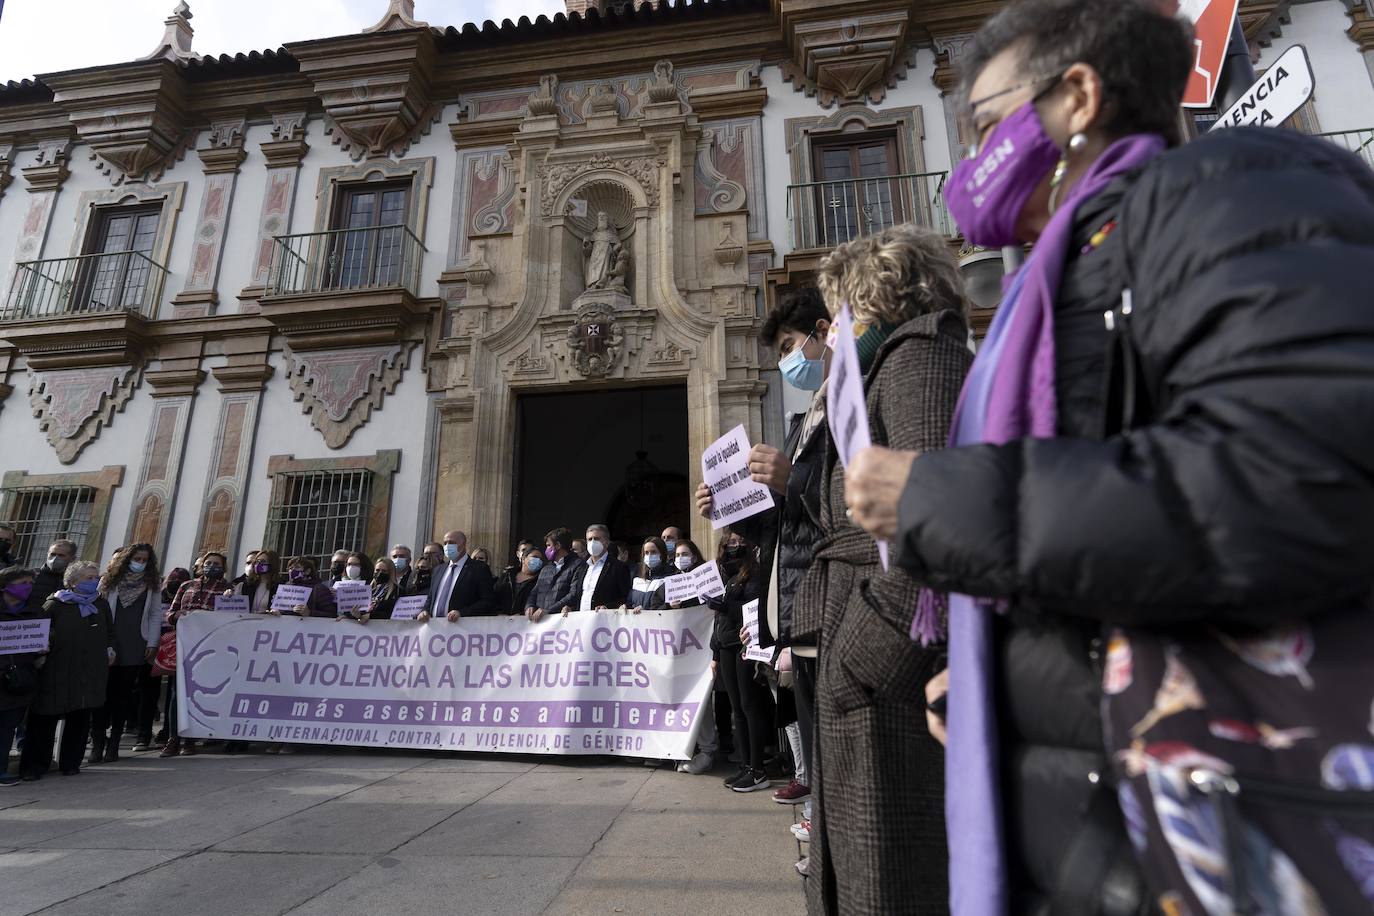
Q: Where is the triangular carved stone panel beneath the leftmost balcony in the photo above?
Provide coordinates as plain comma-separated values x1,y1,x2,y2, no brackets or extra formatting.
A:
29,365,140,464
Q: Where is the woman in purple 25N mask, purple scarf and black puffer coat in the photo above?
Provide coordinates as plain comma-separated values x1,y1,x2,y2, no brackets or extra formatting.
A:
845,0,1374,916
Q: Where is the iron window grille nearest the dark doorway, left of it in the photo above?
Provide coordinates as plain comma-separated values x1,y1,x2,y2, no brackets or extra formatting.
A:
267,470,372,573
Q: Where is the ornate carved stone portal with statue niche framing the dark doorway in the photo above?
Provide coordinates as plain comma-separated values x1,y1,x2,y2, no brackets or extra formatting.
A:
431,60,767,554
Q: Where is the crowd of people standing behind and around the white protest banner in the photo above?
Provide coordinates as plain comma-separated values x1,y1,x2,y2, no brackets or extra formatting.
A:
0,525,808,803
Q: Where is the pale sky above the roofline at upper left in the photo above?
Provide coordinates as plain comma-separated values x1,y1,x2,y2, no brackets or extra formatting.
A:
0,0,563,82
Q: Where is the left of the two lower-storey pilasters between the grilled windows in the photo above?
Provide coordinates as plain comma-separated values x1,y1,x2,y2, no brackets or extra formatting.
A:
125,351,205,556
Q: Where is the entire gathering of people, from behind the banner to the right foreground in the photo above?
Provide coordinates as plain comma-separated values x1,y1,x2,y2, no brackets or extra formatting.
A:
0,0,1374,916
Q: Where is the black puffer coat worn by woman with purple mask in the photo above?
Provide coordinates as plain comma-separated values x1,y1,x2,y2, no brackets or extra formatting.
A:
897,129,1374,909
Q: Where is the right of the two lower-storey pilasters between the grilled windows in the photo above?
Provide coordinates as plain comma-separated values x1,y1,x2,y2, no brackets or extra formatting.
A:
195,340,272,558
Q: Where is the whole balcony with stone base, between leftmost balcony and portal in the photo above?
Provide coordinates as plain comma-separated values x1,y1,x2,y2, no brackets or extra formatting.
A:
260,225,430,350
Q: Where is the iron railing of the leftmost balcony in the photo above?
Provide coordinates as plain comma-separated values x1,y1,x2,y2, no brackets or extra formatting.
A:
0,251,168,321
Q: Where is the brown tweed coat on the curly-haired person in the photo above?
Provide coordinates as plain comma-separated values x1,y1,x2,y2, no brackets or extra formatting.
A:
793,310,973,916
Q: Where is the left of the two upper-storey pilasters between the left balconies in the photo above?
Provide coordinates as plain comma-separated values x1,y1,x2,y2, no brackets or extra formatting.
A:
172,118,247,319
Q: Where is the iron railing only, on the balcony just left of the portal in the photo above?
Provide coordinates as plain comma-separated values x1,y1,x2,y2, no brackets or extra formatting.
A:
267,225,425,297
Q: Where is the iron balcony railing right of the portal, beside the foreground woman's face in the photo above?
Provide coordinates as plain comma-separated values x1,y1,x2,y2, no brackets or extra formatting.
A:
787,172,954,250
